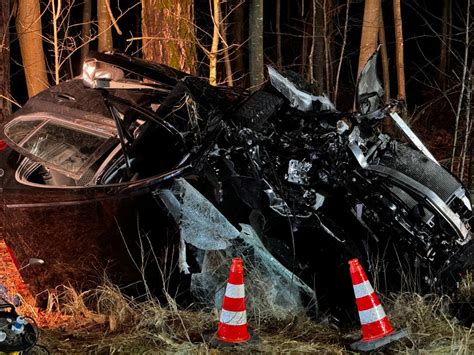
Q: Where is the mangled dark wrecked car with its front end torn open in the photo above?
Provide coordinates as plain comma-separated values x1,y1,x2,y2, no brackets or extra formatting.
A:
1,53,474,318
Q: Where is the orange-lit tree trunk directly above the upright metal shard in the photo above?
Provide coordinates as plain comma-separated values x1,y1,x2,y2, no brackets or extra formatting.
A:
357,0,380,77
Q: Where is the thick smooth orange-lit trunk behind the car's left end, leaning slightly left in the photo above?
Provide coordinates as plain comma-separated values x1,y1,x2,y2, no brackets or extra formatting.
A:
16,0,48,97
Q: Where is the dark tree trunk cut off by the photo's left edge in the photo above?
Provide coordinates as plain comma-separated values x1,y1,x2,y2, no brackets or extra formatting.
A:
0,1,11,122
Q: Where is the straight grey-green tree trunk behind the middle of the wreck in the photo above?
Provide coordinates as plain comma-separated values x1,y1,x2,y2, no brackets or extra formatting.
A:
249,0,265,90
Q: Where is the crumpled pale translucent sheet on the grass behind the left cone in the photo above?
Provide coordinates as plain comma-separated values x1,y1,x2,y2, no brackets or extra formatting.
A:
191,224,317,320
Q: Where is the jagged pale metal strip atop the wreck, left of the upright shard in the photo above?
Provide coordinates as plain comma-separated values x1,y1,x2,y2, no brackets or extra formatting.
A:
268,66,336,112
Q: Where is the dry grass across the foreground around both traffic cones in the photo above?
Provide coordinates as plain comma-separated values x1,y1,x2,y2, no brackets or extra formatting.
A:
28,276,474,354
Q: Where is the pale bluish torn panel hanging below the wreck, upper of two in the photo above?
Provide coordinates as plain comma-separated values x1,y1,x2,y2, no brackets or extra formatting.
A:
154,178,240,250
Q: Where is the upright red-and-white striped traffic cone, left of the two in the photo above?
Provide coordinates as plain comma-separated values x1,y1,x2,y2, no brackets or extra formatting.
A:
215,258,250,343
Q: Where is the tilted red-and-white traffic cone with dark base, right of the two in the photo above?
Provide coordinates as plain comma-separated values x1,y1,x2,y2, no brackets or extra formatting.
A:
349,259,407,351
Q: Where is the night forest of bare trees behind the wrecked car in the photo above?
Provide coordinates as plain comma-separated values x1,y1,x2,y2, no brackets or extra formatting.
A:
0,0,473,182
